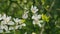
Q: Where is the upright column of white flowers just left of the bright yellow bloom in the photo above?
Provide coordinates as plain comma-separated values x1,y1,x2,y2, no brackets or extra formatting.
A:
31,6,44,27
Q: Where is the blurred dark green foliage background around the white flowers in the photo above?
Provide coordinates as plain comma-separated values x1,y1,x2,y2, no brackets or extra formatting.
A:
0,0,60,34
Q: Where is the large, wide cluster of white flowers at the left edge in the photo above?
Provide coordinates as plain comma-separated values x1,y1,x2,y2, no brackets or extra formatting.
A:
0,14,26,33
